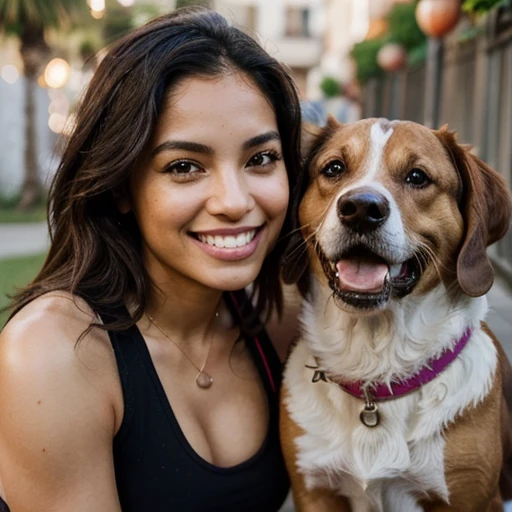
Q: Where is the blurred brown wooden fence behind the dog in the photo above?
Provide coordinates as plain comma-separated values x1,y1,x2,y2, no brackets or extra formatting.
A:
363,8,512,280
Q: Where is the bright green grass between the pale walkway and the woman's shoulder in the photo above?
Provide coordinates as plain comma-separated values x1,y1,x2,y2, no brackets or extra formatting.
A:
0,254,45,329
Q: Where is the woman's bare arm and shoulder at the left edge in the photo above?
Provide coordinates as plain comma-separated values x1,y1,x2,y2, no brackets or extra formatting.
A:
0,296,122,512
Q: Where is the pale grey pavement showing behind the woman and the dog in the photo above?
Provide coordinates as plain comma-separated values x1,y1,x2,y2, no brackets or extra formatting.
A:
0,222,512,512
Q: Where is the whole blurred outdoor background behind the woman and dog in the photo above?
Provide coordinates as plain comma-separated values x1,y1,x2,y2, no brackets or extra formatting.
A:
0,0,512,510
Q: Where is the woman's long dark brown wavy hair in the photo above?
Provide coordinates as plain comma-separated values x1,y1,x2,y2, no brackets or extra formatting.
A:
10,8,300,330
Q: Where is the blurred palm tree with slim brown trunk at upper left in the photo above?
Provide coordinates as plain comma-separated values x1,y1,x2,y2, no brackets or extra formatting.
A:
0,0,87,209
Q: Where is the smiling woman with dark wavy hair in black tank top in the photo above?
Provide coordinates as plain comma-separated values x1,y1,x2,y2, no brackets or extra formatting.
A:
0,9,300,512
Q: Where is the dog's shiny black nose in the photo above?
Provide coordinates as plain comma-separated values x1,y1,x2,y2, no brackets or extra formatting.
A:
338,187,389,233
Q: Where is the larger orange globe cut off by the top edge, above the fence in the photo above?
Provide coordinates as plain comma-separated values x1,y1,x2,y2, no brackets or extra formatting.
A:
415,0,461,37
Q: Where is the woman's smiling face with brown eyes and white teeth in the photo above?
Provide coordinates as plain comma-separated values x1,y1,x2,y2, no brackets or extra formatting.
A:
121,73,289,290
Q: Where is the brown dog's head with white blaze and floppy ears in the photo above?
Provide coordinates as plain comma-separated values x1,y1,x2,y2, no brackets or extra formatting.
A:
283,118,511,312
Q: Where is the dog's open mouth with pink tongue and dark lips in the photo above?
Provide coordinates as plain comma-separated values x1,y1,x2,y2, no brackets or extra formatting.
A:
318,246,423,309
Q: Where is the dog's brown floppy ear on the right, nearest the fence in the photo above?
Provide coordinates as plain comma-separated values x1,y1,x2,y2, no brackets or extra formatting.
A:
434,126,512,297
